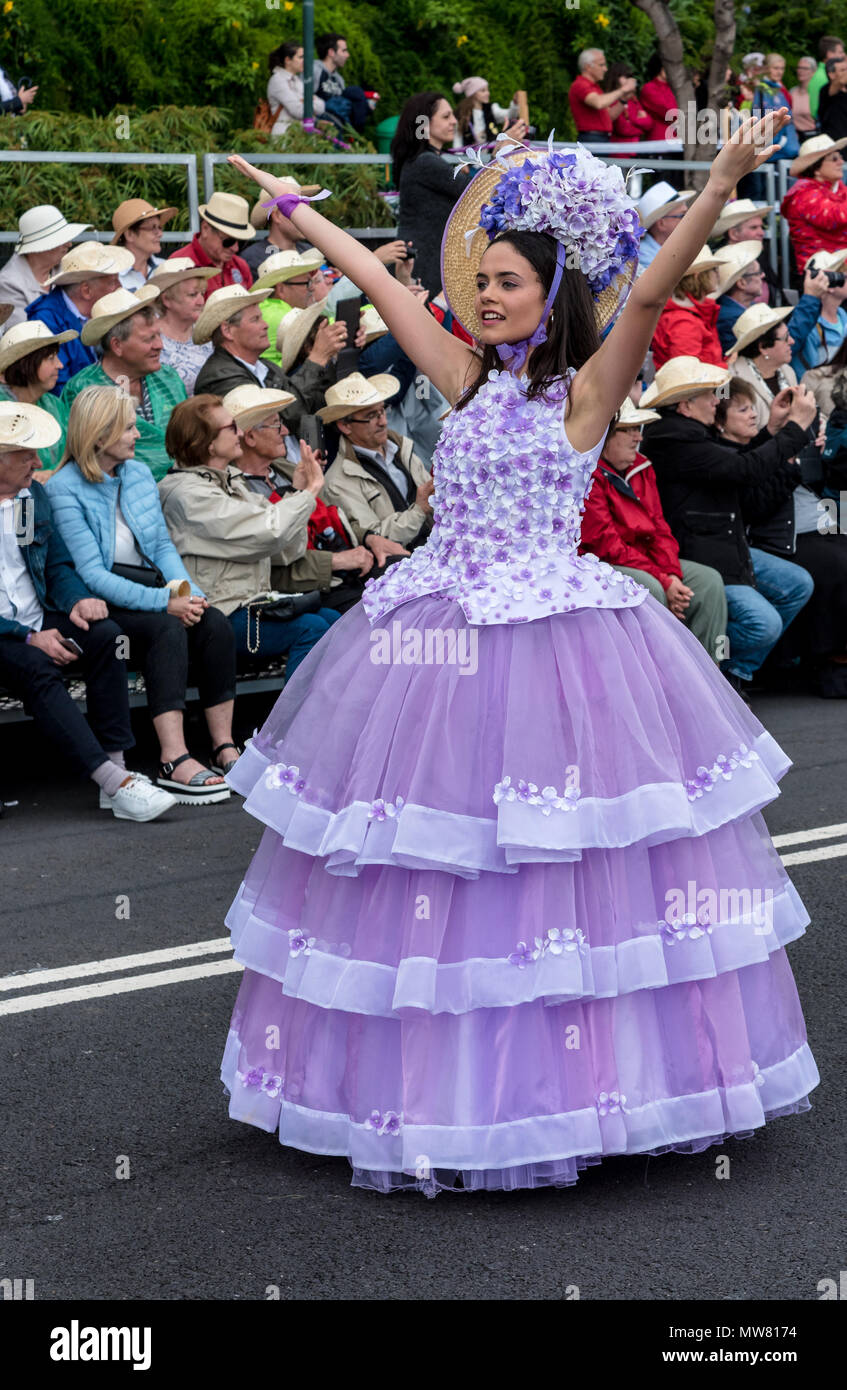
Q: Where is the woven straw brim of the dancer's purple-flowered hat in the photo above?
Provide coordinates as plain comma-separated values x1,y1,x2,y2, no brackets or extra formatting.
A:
441,146,636,339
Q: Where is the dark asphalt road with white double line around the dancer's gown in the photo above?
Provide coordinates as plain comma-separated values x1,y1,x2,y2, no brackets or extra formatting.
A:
0,695,847,1300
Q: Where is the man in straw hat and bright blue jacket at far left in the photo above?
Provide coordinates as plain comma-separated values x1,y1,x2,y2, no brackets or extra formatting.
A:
26,242,132,396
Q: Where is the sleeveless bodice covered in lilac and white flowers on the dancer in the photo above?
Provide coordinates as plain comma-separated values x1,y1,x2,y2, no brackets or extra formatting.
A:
362,368,647,624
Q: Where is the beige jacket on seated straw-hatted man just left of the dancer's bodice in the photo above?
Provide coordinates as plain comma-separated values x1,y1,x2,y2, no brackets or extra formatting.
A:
321,430,433,545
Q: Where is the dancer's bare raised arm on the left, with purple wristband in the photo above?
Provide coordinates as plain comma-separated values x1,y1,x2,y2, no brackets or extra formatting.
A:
229,154,476,403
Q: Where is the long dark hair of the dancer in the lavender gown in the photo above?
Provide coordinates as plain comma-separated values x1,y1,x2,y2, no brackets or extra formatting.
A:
456,231,599,414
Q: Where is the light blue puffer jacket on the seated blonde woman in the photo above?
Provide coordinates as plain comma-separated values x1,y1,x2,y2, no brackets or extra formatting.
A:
47,459,204,613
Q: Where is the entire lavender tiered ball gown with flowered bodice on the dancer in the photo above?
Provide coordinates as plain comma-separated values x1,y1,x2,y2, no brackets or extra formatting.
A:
221,373,819,1195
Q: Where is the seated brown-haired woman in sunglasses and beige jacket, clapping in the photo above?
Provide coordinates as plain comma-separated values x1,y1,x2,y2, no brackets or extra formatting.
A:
159,395,338,678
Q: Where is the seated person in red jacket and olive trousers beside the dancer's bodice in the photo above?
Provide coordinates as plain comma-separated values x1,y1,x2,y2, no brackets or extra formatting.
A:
580,396,726,662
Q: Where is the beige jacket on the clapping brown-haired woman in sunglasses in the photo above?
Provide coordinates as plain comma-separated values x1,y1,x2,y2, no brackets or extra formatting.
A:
159,463,314,616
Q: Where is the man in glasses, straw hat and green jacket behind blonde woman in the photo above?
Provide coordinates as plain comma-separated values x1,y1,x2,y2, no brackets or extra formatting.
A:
63,285,185,480
